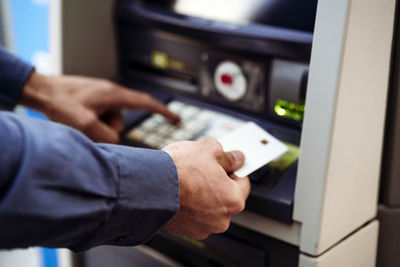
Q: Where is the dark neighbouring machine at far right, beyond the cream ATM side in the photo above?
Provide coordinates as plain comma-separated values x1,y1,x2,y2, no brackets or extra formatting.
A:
377,4,400,267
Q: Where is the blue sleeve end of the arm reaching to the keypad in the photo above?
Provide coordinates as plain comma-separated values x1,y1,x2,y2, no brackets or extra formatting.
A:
0,47,33,110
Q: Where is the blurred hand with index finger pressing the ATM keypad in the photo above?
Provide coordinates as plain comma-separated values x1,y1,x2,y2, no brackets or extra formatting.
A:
20,72,179,143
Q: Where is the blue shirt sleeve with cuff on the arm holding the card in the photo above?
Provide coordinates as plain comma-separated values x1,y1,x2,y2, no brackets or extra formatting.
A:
0,112,179,251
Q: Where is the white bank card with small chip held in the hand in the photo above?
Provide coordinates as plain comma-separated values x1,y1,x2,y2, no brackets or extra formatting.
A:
218,122,288,177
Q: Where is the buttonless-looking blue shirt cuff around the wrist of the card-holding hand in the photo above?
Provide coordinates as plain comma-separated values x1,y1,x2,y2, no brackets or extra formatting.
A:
80,145,179,250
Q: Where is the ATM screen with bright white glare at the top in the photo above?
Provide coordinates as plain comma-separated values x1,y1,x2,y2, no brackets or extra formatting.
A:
143,0,318,32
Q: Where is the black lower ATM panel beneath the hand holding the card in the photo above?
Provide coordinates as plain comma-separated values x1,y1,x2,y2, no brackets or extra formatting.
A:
147,225,299,267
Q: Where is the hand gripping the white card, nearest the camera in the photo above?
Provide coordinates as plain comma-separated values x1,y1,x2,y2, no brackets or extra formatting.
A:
163,139,250,239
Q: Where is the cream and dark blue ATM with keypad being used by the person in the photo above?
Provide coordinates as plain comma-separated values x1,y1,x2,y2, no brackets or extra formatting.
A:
51,0,396,267
